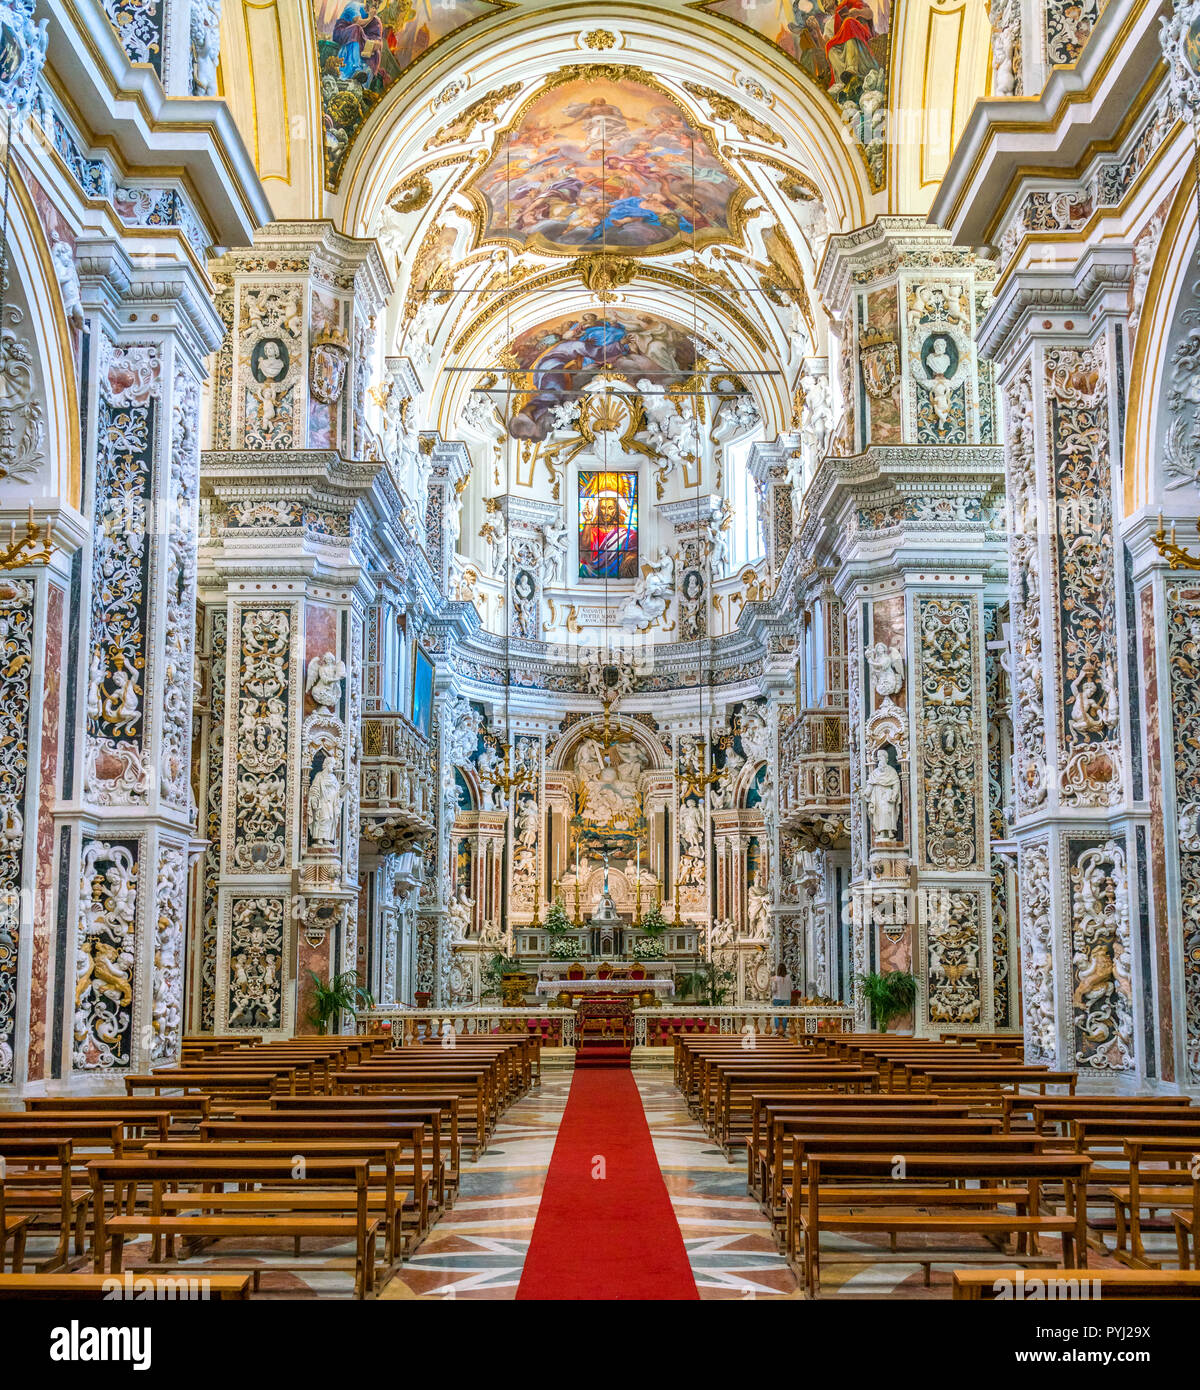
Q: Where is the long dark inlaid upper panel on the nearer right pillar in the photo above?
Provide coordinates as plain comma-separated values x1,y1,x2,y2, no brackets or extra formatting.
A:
1046,343,1121,806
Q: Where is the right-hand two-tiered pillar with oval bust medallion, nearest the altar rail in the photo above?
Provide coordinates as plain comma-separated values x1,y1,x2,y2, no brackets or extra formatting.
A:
817,217,1004,1034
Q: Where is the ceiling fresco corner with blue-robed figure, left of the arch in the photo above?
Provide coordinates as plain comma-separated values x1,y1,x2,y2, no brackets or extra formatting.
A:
313,0,510,192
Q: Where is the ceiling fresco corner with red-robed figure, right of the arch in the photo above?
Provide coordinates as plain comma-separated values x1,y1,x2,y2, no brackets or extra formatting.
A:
695,0,891,189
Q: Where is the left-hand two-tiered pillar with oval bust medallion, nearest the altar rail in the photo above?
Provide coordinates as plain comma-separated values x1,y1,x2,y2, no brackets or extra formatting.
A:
197,224,383,1036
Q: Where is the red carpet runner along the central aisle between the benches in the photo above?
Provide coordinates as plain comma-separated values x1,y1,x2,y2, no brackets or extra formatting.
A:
517,1068,699,1300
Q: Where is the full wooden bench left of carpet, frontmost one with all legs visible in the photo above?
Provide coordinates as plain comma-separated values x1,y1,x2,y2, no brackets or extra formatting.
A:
89,1156,381,1298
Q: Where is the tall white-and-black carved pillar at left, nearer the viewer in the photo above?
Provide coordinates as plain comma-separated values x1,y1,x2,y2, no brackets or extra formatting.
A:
54,240,220,1072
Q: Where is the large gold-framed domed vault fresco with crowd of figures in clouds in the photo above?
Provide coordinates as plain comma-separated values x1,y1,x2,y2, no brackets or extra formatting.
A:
471,78,745,254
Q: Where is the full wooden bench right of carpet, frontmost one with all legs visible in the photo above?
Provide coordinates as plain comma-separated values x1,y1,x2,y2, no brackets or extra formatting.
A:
801,1136,1092,1297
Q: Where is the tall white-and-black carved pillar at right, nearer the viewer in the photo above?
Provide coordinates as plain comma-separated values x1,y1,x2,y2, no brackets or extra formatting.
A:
986,247,1151,1077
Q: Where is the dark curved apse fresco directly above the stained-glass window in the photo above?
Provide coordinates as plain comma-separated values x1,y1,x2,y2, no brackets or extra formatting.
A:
509,309,697,439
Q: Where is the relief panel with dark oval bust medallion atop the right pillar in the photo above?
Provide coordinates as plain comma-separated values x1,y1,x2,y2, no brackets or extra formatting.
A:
905,281,975,445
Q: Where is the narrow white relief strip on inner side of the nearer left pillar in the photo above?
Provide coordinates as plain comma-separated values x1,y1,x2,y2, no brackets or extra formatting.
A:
160,373,200,808
